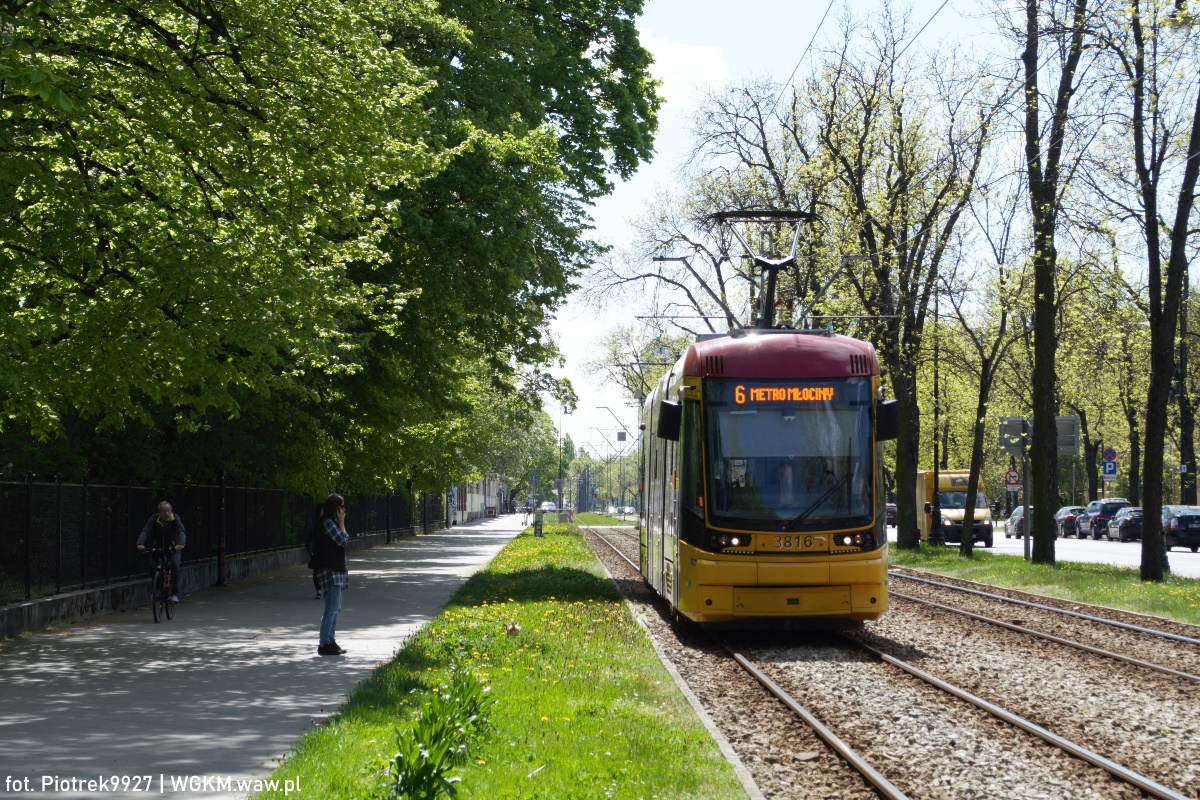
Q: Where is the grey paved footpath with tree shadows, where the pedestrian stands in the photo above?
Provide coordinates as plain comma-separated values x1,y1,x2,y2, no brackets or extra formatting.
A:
0,515,522,800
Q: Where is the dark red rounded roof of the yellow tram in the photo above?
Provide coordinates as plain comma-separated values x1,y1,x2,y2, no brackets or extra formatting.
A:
683,330,878,379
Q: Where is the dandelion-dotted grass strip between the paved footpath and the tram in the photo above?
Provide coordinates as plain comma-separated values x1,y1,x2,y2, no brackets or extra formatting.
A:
254,524,745,800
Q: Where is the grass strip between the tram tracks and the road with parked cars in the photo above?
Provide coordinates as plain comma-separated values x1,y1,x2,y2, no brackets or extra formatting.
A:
888,545,1200,625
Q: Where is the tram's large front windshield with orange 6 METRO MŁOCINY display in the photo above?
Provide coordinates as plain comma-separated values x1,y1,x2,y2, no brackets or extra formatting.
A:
704,378,875,530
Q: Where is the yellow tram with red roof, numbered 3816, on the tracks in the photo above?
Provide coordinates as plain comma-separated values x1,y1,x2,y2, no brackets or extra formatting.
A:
640,329,895,624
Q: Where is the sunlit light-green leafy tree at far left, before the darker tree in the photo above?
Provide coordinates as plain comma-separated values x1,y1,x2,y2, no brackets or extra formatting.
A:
0,0,457,437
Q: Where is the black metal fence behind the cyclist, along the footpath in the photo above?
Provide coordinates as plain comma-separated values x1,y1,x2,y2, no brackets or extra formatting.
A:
0,481,443,603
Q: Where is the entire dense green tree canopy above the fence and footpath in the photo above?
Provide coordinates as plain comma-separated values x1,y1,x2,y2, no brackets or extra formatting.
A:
0,0,659,491
